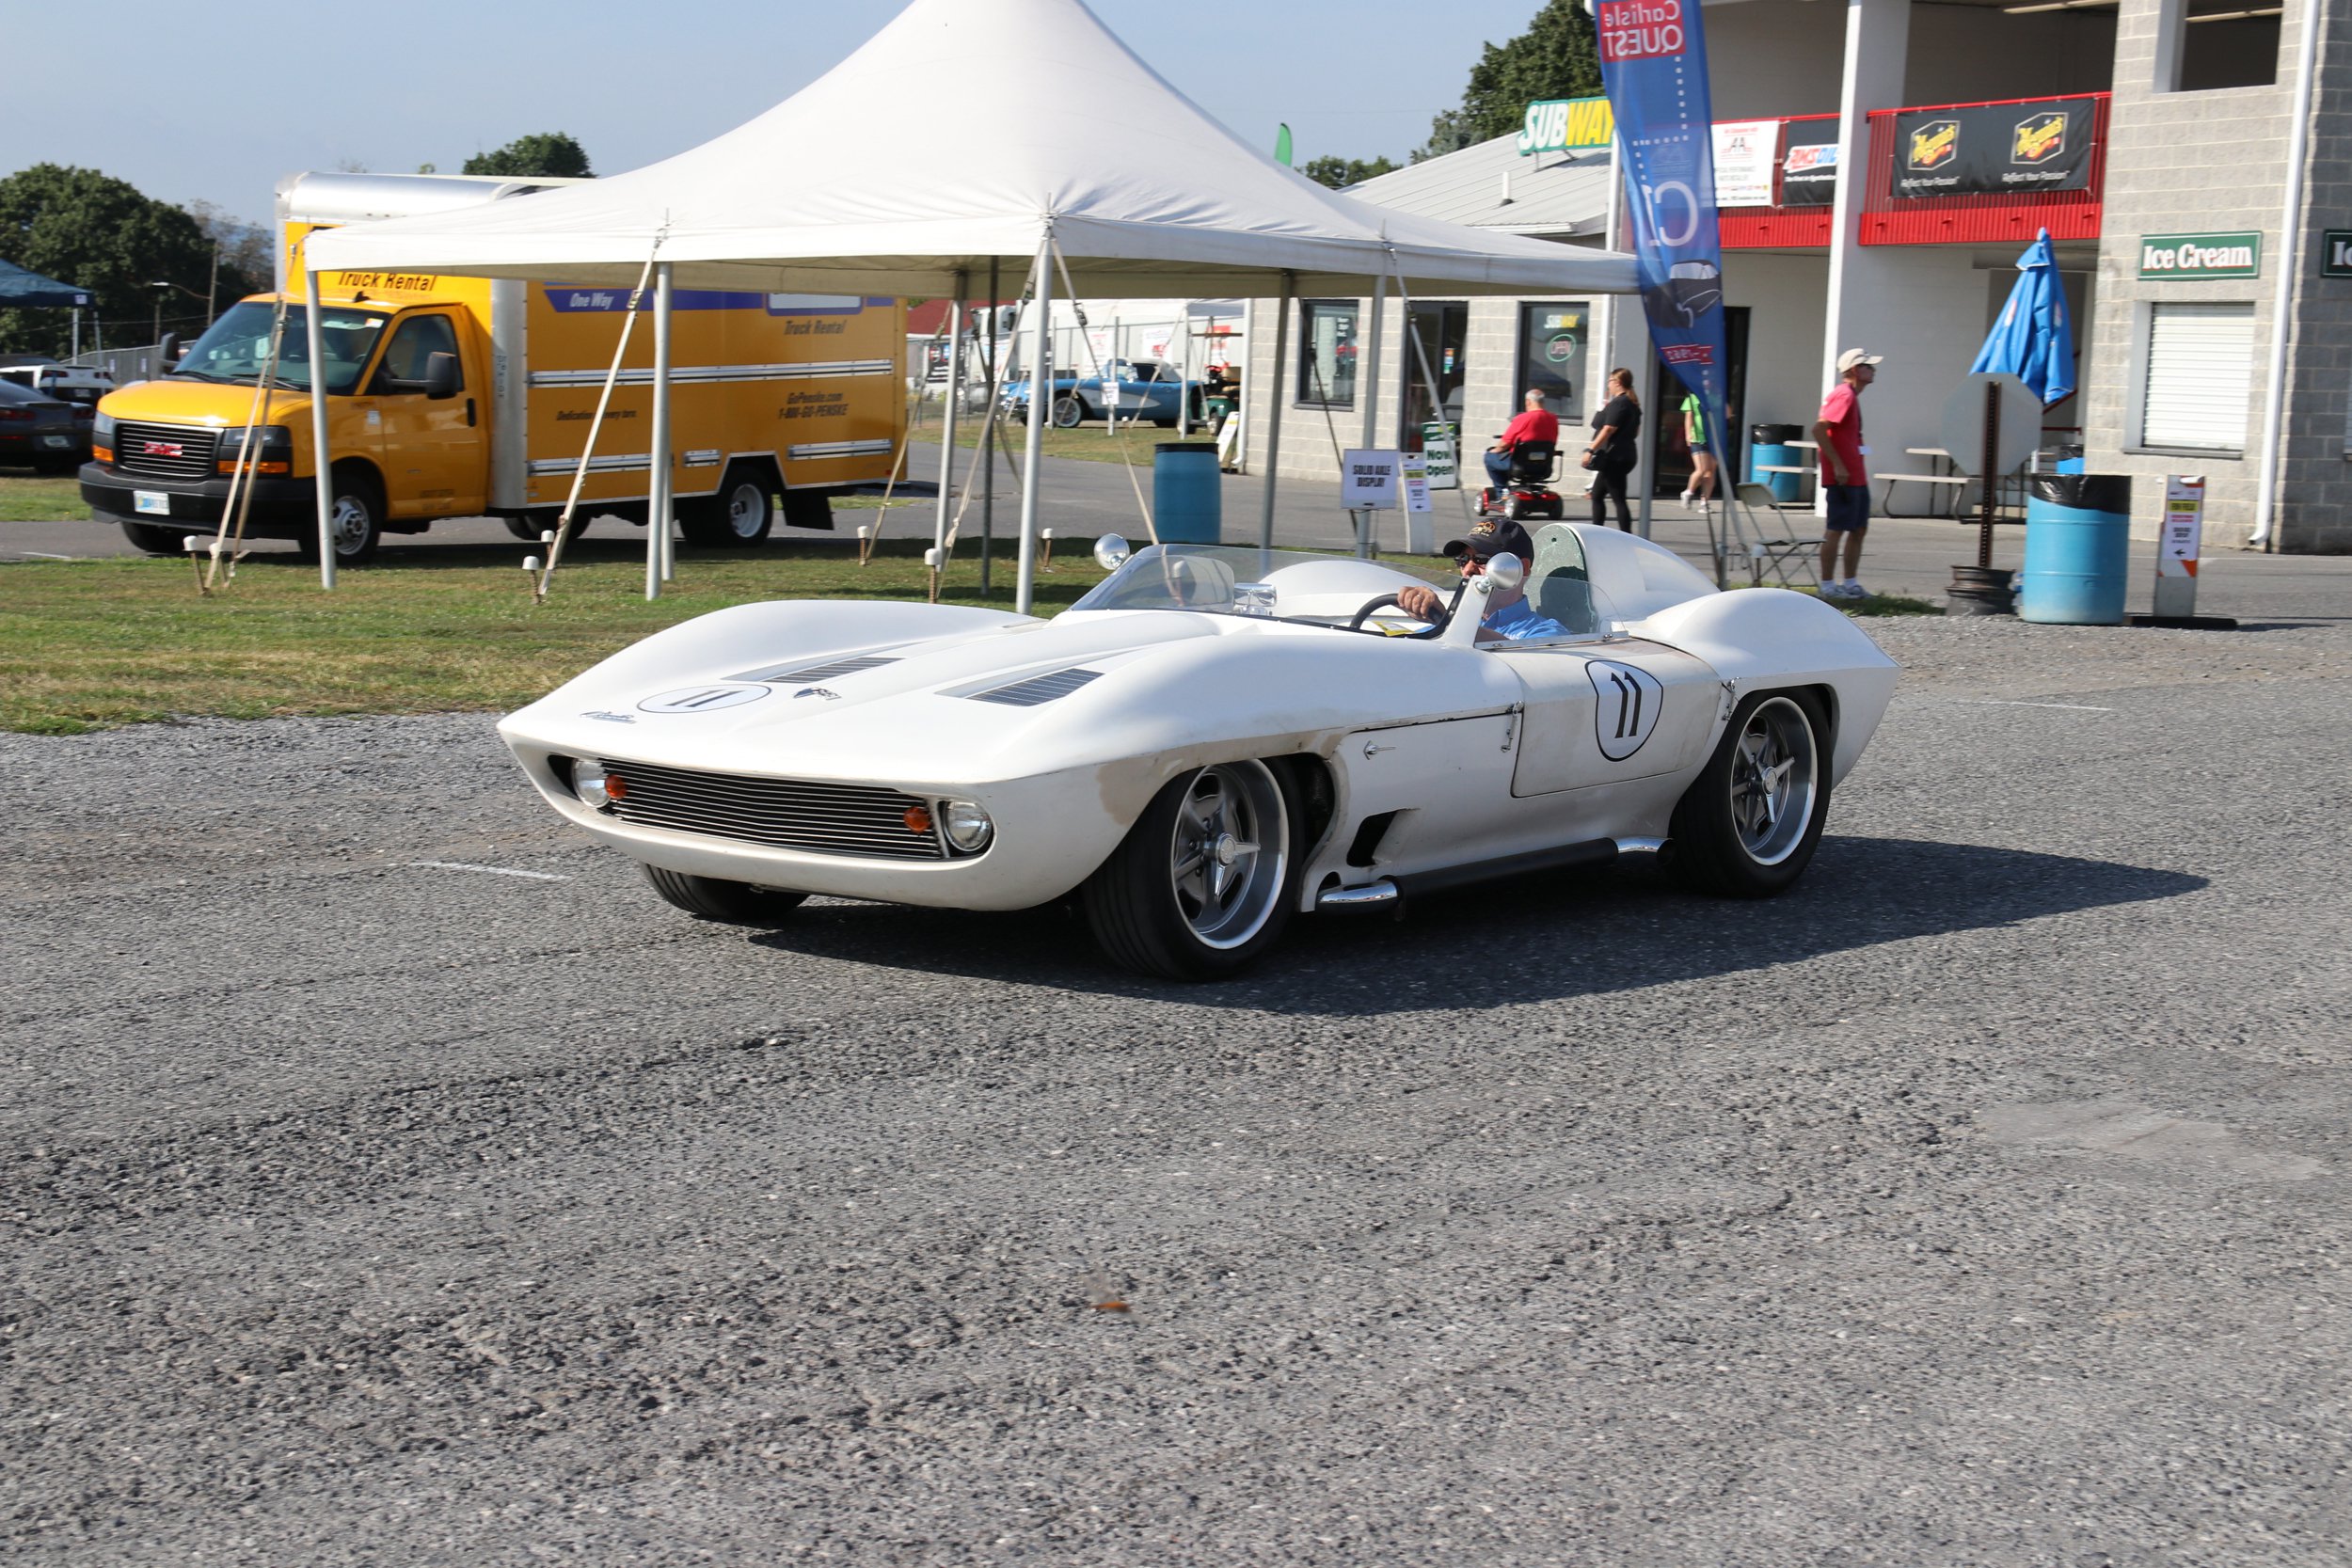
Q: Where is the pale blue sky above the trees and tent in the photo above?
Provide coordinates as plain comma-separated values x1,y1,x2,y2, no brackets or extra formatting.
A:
23,0,1541,221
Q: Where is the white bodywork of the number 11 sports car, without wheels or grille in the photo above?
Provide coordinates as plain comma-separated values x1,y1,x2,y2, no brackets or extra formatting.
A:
499,524,1896,910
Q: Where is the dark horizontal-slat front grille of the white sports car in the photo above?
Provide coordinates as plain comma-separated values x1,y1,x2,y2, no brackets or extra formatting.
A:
602,757,948,861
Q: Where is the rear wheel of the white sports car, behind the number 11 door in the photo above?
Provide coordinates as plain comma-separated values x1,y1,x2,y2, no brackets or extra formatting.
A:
1665,691,1830,898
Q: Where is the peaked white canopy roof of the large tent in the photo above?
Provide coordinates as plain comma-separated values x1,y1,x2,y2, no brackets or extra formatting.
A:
306,0,1635,298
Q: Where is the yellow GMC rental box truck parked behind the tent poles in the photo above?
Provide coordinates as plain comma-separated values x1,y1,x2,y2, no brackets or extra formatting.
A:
83,174,906,564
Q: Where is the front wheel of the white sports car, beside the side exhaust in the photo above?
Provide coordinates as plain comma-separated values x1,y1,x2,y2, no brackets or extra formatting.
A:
1082,762,1301,980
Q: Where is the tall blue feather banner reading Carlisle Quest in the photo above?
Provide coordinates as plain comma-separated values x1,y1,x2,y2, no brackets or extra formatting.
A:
1595,0,1731,441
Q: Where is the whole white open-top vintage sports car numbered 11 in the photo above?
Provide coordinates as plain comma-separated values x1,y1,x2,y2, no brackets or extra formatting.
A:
499,524,1896,978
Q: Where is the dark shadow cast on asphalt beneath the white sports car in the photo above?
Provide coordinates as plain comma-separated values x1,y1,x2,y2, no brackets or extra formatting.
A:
751,834,2206,1016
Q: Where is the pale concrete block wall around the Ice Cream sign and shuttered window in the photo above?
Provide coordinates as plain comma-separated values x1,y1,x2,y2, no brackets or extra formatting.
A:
2082,0,2296,546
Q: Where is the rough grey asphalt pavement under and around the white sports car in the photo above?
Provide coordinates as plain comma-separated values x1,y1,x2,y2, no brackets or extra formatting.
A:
0,606,2352,1568
